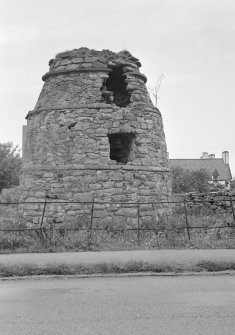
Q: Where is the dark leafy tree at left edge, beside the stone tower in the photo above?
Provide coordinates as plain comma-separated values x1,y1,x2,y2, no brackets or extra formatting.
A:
0,142,22,192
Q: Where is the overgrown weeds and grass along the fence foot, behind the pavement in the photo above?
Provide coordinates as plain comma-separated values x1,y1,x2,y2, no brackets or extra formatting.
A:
0,228,235,253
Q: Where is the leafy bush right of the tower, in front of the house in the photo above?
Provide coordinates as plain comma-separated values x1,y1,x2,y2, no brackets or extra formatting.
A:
172,166,209,193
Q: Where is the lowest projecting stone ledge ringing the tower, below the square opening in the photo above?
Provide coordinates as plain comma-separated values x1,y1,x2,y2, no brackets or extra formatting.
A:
22,164,171,172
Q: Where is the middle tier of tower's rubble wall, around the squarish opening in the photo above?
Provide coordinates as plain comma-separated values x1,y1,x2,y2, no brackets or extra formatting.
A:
24,104,167,168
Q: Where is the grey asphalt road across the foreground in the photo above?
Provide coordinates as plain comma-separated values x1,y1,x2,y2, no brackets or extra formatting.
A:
0,275,235,335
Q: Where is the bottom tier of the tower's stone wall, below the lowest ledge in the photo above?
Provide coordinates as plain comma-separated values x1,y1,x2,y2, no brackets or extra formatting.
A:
20,169,171,229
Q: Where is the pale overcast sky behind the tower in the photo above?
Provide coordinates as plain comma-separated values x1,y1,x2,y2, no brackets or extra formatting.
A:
0,0,235,175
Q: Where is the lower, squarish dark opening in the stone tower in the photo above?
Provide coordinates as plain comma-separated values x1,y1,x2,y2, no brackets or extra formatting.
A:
108,133,135,163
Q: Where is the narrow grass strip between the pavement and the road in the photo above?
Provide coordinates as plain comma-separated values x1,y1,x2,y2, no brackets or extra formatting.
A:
0,261,235,278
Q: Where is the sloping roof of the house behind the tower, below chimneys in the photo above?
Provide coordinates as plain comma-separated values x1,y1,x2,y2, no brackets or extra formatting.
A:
169,158,232,181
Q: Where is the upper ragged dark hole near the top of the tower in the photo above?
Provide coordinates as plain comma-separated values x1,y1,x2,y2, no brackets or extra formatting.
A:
101,66,131,107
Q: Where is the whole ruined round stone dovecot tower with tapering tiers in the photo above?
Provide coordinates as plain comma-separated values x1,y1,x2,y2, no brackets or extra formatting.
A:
21,48,171,228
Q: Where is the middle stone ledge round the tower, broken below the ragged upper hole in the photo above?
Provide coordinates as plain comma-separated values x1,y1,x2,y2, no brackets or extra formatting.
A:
25,102,161,119
